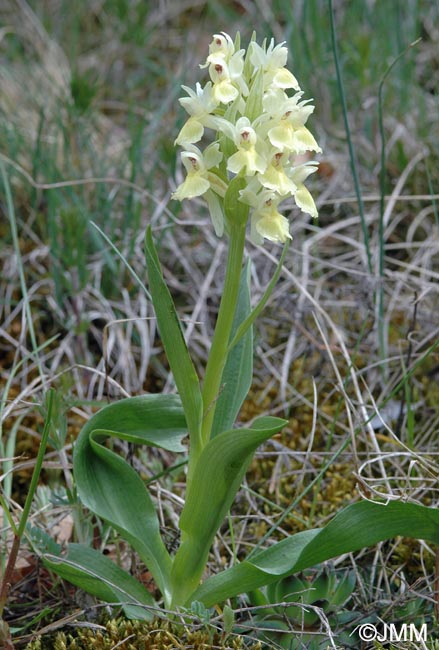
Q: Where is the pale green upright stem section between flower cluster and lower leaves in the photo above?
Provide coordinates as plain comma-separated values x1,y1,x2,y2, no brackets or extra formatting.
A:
201,223,245,446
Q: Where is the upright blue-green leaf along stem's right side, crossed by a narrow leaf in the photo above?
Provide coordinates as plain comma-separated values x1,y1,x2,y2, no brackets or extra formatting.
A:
211,260,253,438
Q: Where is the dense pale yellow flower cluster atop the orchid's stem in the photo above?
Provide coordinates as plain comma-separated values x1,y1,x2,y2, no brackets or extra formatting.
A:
172,32,321,244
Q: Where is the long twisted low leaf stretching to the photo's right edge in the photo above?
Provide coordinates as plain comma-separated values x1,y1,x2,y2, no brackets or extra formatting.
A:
192,501,439,607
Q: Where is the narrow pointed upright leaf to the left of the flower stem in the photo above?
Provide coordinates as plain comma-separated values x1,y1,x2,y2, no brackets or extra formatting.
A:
145,227,203,446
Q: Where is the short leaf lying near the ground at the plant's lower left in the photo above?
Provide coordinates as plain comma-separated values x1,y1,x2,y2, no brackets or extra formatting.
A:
42,544,155,620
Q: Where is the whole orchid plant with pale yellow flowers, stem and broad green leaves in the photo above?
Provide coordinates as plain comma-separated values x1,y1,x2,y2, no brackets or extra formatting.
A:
43,32,439,618
